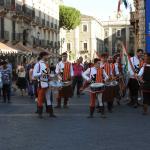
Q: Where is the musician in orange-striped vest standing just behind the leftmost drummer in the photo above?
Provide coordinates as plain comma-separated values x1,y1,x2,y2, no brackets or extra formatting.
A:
55,53,74,108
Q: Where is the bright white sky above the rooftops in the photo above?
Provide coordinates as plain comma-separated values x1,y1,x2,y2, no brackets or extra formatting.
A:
63,0,133,20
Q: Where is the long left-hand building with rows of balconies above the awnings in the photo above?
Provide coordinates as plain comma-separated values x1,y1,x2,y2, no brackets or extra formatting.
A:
0,0,61,62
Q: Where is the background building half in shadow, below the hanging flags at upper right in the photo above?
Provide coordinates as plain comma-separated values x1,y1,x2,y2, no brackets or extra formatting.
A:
103,13,135,55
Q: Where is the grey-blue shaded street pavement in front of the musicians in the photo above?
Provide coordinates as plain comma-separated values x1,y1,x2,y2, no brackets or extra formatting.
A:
0,94,150,150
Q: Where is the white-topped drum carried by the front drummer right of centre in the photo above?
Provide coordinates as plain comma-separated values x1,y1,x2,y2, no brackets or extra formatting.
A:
90,83,105,92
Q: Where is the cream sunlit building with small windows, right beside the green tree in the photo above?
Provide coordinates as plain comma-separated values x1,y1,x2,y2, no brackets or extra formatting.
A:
63,15,104,61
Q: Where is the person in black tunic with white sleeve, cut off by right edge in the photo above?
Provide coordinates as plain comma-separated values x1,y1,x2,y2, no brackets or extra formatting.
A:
138,54,150,115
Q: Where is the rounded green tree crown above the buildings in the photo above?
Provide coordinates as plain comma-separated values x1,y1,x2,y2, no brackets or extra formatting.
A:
59,5,81,30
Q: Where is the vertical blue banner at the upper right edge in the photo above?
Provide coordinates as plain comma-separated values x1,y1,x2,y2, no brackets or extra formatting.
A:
145,0,150,53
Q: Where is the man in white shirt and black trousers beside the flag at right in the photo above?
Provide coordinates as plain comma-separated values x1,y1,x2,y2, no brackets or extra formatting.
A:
128,49,143,108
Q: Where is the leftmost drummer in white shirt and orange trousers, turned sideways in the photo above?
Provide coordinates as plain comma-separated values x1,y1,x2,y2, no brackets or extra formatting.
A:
33,52,55,118
